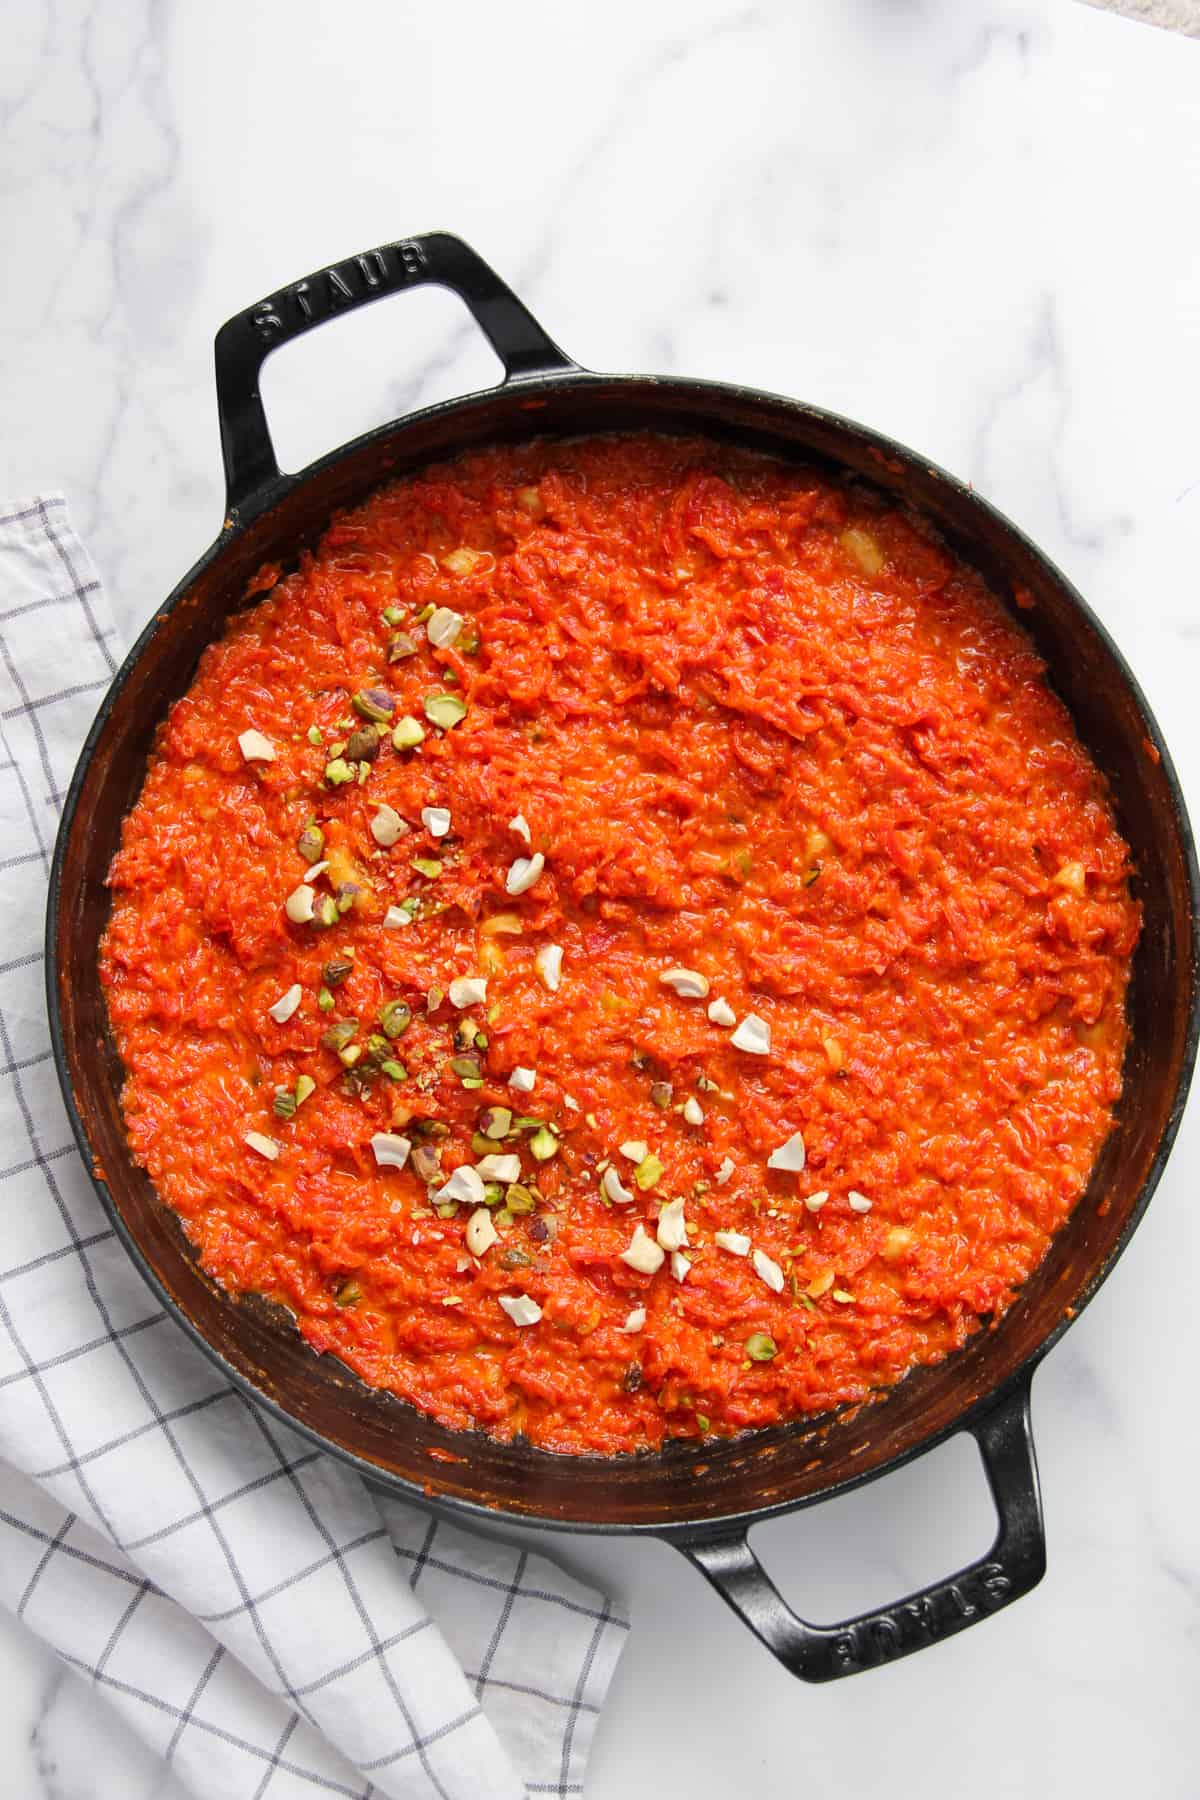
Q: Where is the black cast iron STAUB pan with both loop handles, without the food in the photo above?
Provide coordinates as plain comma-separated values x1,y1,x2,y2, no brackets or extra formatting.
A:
47,232,1198,1681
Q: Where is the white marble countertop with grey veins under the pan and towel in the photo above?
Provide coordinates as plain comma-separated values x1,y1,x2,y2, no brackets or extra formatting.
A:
0,0,1200,1800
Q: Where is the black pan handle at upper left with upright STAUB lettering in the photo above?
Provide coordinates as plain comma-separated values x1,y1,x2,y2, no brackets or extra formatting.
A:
216,230,578,517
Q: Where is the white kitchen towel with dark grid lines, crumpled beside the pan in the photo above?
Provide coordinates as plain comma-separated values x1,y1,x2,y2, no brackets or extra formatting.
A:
0,495,628,1800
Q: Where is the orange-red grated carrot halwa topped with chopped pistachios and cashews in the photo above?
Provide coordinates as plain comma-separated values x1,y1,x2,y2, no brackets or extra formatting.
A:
101,436,1139,1453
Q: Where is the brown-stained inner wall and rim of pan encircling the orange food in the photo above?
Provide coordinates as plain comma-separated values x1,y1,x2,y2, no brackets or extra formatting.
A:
50,376,1196,1530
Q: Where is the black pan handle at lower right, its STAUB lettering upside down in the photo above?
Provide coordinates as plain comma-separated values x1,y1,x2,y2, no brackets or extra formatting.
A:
673,1375,1045,1681
